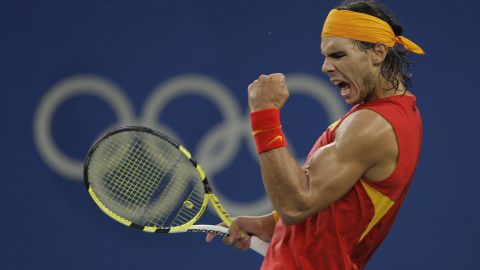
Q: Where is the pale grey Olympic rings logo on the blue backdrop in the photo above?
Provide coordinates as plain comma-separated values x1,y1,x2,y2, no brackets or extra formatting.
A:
33,74,346,215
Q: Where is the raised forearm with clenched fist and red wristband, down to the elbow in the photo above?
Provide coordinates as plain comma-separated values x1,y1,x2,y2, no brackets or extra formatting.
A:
248,73,311,223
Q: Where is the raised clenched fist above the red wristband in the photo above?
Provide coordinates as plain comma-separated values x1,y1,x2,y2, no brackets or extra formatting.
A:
248,73,289,112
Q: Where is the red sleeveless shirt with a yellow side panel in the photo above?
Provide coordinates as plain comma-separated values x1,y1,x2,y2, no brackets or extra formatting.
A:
261,95,422,270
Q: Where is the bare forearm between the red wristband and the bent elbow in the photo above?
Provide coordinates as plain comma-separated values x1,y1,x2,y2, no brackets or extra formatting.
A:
260,147,310,224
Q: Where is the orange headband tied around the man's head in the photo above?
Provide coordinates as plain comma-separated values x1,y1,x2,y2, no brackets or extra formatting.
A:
322,9,425,54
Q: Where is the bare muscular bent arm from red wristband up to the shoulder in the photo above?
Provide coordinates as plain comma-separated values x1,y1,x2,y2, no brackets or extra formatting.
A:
260,110,398,224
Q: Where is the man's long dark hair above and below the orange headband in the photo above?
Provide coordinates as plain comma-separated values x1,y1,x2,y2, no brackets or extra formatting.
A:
336,0,412,91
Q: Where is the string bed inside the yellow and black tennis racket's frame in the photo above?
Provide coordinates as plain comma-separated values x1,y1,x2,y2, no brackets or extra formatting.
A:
89,132,204,227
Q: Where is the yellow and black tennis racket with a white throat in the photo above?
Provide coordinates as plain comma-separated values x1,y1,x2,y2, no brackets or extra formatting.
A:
84,126,268,256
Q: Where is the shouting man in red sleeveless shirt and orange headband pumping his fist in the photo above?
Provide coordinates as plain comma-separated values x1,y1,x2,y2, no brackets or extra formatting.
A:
207,1,424,270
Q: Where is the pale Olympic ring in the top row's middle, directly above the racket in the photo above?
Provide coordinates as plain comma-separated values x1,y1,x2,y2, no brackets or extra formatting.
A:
141,75,241,175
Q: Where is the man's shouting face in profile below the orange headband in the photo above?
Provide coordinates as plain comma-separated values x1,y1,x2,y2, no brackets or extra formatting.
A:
321,37,379,105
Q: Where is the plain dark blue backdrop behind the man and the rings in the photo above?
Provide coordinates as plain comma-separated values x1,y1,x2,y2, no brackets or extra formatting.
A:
0,0,480,269
